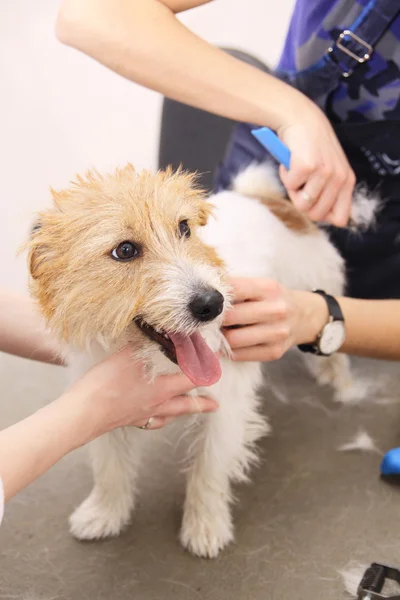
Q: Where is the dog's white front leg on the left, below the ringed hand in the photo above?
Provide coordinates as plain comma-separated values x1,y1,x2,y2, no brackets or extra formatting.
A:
69,428,140,540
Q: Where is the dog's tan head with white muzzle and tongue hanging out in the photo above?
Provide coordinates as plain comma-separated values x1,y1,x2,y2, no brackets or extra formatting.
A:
29,165,226,385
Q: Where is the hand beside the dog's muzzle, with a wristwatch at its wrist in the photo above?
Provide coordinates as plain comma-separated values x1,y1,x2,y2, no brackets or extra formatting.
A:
224,279,329,362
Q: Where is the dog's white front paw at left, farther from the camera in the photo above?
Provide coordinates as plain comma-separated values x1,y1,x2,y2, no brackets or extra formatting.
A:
69,493,131,540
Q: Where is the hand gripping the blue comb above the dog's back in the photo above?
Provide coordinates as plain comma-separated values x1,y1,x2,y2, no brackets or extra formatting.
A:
277,92,356,227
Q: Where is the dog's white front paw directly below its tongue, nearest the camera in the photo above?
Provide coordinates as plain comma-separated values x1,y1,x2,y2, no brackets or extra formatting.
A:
180,509,234,558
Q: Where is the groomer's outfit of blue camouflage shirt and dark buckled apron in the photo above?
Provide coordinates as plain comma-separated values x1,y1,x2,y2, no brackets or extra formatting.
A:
214,0,400,298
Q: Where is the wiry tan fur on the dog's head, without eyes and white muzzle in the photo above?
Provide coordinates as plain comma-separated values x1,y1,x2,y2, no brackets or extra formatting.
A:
28,164,223,346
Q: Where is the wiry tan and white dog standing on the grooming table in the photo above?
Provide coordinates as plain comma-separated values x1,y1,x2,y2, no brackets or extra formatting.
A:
28,164,376,558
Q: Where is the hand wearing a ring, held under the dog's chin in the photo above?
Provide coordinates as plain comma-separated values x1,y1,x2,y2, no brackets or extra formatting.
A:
66,346,218,445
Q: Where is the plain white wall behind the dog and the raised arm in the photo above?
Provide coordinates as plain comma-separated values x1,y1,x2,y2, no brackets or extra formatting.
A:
0,0,294,291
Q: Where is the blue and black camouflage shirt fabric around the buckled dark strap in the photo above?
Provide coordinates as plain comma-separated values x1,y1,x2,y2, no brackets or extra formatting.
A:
277,0,400,123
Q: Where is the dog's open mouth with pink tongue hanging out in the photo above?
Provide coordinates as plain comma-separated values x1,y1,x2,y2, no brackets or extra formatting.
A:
135,319,221,386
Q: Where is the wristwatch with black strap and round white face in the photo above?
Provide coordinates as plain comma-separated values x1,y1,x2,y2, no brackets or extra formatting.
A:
298,290,346,356
